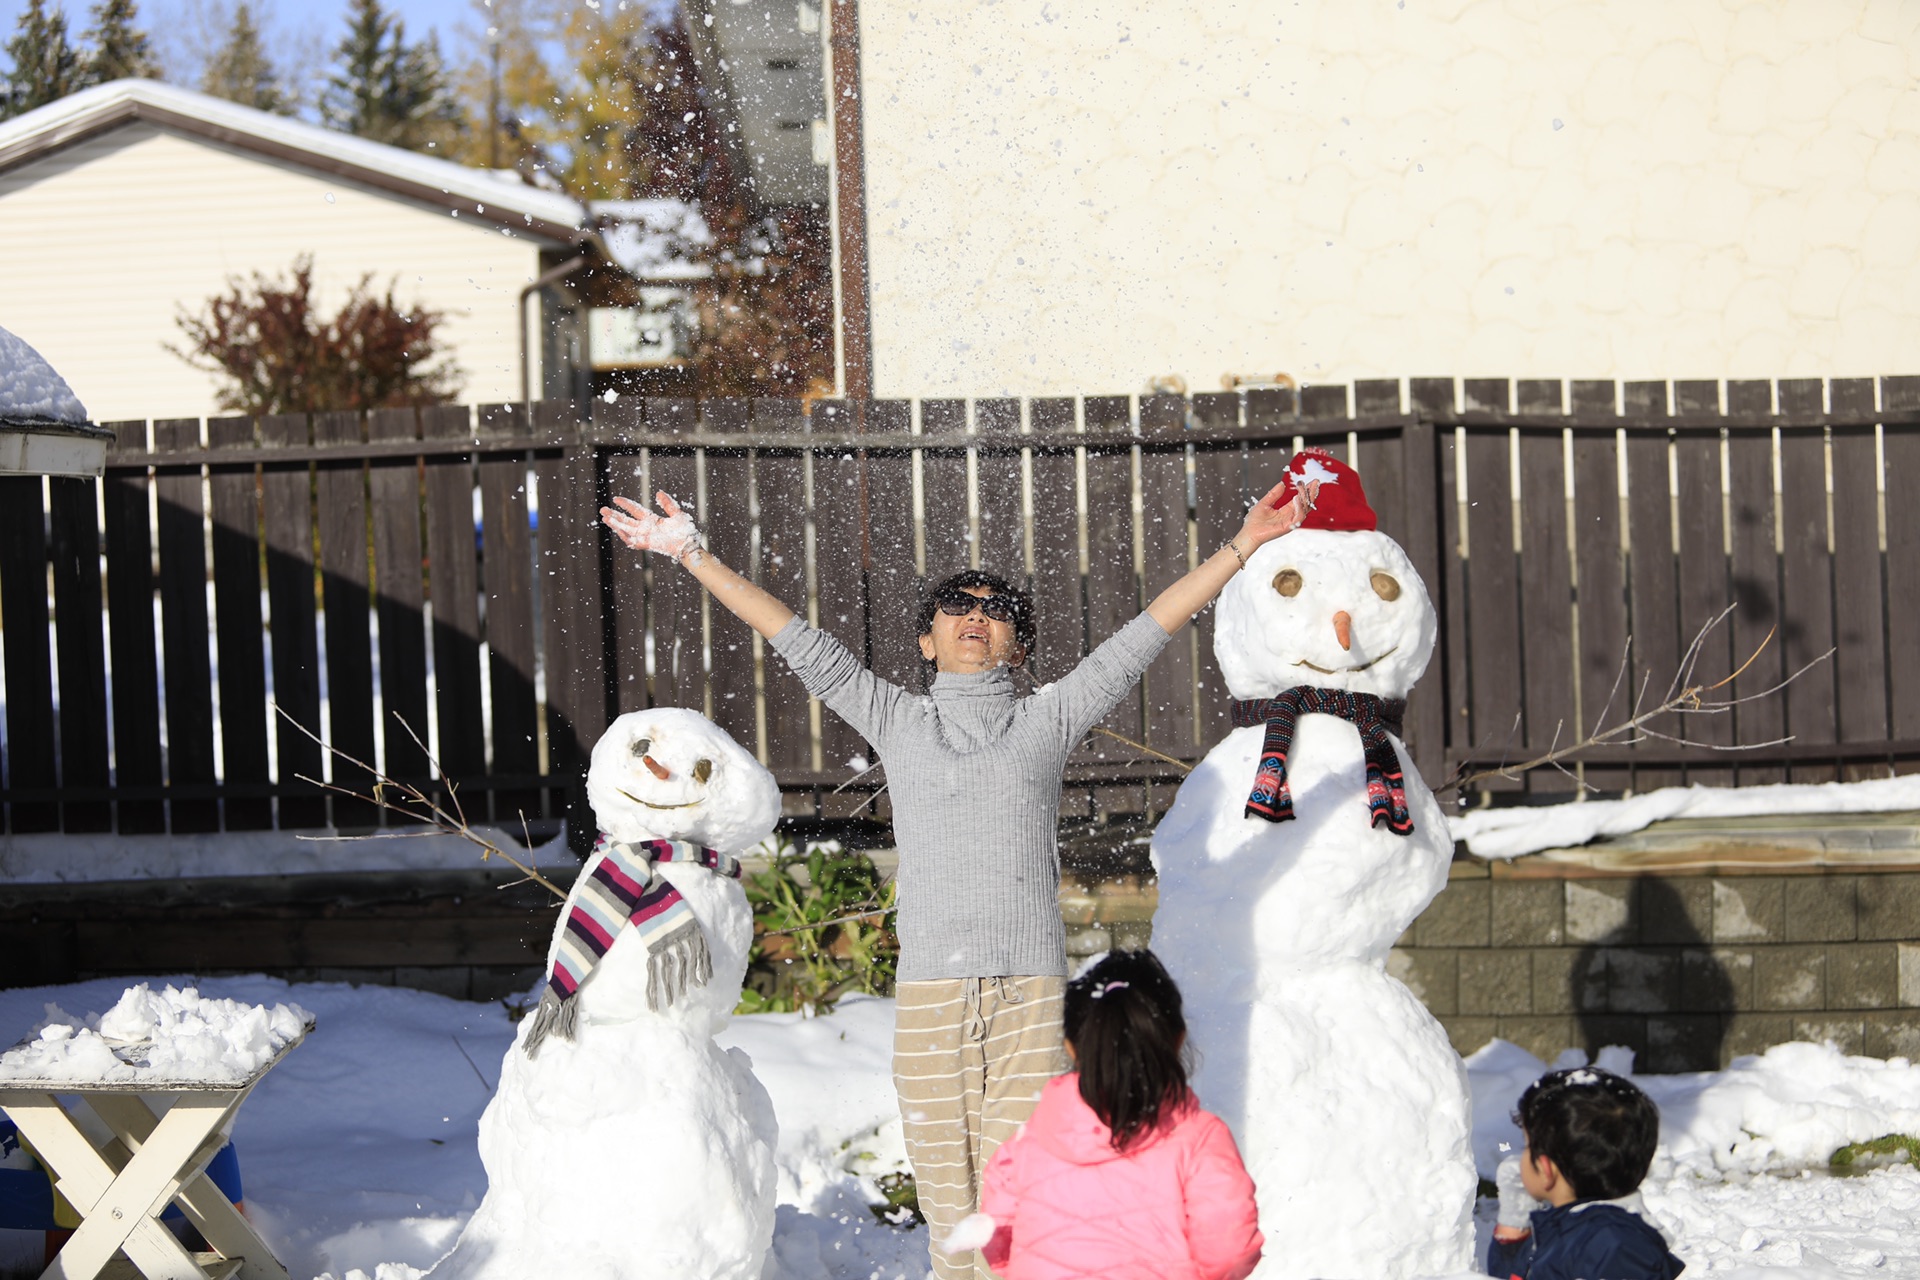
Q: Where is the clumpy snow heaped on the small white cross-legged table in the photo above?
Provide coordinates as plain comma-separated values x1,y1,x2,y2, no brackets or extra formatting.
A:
0,983,313,1084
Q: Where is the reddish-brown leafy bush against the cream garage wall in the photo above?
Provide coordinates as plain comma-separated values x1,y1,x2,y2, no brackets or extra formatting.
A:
167,255,463,415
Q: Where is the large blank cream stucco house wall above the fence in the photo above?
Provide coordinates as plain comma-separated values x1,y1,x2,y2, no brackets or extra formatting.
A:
860,0,1920,395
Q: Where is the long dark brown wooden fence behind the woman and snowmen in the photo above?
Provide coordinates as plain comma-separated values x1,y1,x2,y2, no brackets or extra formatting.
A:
0,378,1920,833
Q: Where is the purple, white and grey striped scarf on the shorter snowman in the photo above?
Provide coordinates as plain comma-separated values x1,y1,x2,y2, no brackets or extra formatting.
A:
526,831,739,1057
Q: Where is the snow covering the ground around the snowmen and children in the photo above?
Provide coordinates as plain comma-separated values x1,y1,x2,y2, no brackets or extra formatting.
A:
0,977,1920,1280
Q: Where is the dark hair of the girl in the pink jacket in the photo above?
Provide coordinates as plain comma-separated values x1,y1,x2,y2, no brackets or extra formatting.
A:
1064,952,1190,1151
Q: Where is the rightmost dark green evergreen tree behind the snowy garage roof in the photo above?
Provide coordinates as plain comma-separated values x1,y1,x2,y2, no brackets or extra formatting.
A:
321,0,461,150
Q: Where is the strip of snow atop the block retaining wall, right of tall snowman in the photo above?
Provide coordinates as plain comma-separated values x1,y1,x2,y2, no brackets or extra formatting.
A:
1452,775,1920,858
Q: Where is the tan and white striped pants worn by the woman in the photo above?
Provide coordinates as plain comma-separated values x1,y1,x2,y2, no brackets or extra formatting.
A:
893,977,1068,1280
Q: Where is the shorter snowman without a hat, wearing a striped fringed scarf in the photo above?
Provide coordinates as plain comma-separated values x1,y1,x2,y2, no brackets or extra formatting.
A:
432,708,780,1280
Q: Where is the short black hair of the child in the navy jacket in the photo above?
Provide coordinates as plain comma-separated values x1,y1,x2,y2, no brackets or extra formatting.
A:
1513,1067,1661,1199
